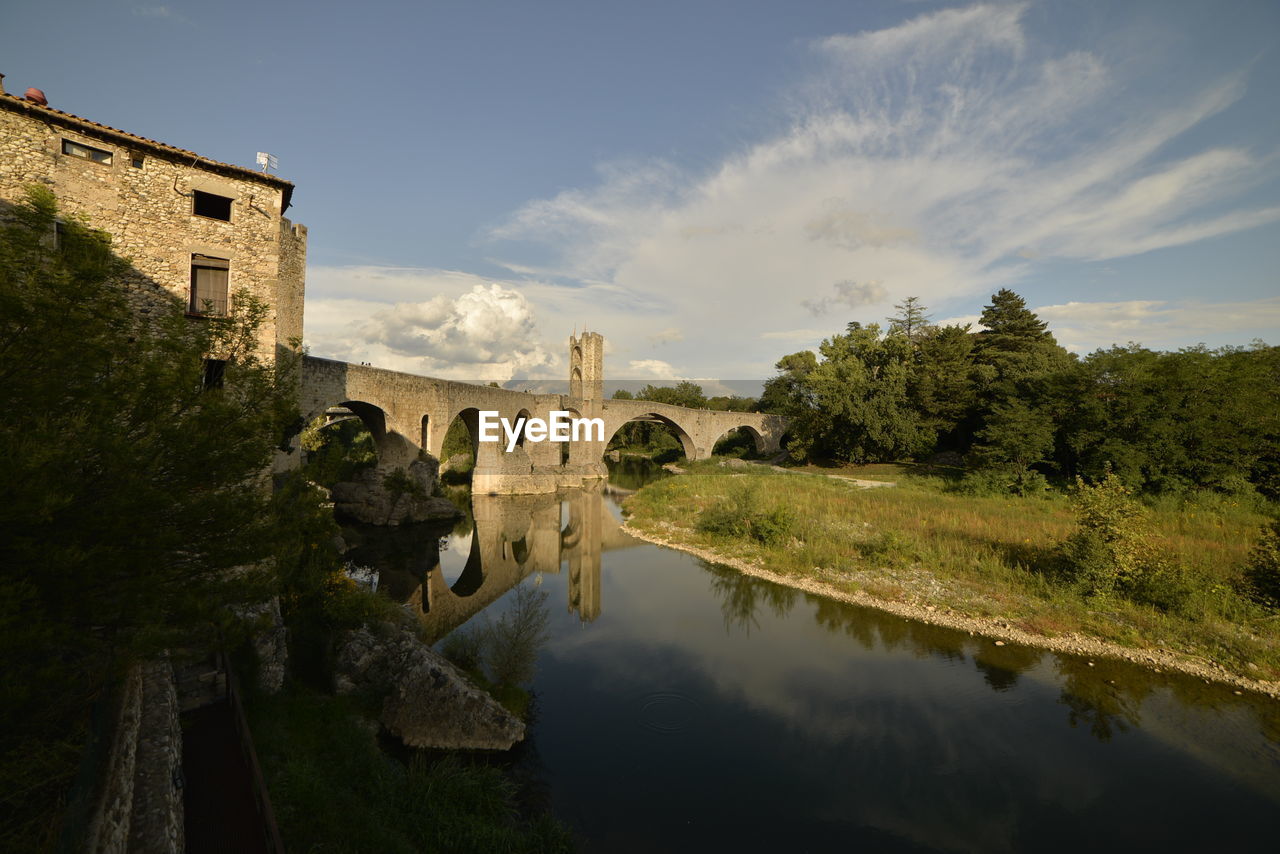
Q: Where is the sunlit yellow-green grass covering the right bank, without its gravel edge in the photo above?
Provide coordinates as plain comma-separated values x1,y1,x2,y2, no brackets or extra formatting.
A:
626,461,1280,679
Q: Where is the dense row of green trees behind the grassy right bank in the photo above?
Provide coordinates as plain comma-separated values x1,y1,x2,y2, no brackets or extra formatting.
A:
760,289,1280,499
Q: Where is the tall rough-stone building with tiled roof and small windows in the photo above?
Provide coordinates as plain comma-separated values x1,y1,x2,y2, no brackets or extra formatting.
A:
0,74,307,363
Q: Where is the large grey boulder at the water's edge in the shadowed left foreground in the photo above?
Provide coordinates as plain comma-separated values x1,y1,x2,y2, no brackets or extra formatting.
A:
334,624,525,750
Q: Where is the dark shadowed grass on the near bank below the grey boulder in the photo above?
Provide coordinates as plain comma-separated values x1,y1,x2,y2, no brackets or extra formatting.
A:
247,685,573,854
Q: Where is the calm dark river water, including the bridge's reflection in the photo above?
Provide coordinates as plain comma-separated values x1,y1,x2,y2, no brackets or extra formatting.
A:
350,468,1280,851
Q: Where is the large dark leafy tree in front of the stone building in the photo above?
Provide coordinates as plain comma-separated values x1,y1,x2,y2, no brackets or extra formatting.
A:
0,188,297,848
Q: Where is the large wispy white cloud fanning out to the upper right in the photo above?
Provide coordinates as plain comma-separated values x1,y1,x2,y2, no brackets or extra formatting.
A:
490,4,1280,373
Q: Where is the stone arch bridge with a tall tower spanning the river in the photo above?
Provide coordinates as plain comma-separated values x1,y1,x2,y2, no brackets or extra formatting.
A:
301,333,786,494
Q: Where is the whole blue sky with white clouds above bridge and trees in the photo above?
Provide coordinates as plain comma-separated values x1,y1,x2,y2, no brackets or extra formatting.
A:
0,0,1280,380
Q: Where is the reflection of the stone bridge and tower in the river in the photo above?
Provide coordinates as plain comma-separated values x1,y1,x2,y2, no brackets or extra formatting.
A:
352,484,643,643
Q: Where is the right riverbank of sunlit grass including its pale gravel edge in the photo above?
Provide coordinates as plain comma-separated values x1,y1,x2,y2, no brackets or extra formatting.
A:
625,466,1280,699
